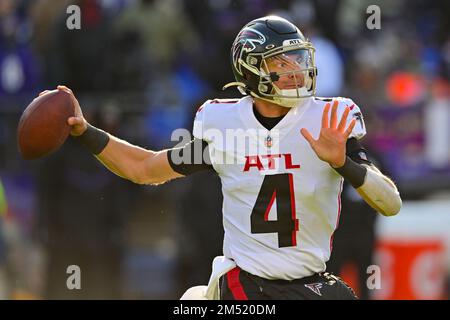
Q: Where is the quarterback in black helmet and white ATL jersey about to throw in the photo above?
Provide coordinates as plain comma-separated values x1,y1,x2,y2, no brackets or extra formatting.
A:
51,16,402,299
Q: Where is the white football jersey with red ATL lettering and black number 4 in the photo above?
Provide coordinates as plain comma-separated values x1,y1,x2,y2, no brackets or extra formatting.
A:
193,96,366,280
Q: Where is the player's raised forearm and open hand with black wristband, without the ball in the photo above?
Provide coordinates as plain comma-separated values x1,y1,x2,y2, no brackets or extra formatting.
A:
301,101,402,216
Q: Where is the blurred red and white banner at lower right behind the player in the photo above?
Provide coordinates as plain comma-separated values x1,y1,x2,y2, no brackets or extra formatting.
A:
374,200,450,299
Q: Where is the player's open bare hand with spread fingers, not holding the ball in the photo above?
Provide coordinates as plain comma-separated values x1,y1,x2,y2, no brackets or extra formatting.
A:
300,100,356,168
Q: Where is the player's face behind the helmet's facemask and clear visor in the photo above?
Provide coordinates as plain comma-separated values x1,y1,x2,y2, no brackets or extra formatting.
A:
266,50,309,89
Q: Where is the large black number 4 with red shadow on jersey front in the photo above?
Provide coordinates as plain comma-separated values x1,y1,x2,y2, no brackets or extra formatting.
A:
250,173,298,248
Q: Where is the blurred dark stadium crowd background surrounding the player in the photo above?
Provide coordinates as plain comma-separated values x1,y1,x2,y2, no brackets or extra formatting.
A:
0,0,450,299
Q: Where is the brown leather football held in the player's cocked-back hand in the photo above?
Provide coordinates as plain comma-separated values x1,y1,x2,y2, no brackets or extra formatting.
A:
17,90,75,160
